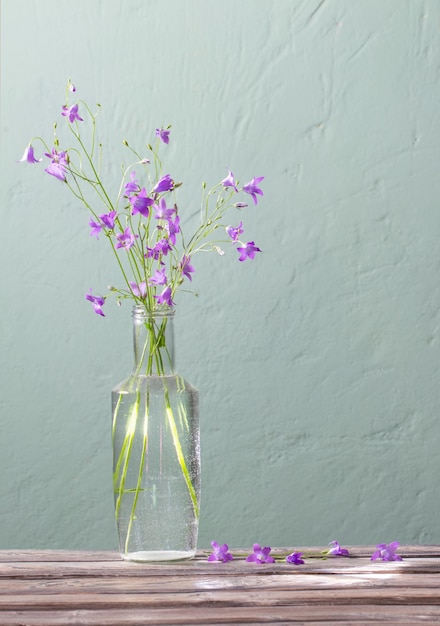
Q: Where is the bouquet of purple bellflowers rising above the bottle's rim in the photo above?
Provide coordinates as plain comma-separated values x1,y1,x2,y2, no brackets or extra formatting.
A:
20,81,264,316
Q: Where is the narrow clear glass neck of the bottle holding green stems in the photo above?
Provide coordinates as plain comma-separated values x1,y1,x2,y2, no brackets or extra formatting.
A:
133,305,174,376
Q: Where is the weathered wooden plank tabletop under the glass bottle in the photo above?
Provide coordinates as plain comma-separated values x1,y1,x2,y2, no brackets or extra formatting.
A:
0,546,440,626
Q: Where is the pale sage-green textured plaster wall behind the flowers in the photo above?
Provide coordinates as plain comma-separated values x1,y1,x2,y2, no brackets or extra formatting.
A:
0,0,440,548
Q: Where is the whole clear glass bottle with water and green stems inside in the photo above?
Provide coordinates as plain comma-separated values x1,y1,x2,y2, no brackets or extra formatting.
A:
112,305,200,561
